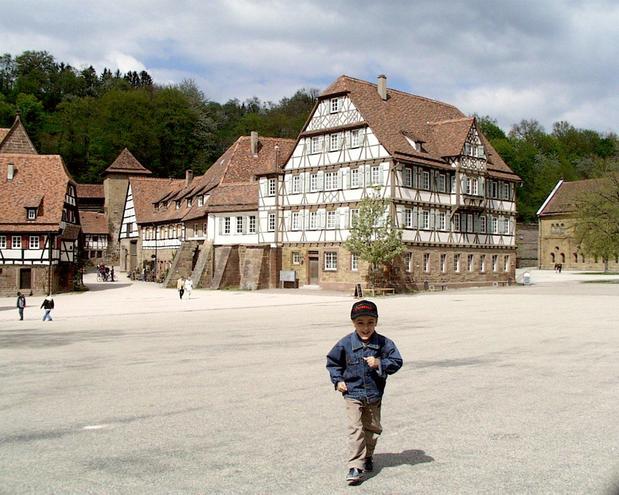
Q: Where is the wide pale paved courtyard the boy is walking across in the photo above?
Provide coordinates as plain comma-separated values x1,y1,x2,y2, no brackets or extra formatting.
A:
0,271,619,495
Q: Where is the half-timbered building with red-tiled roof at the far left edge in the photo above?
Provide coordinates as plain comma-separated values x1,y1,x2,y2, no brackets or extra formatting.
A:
0,152,80,295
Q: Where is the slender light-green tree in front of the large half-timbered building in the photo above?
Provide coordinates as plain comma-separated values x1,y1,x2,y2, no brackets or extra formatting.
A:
344,189,405,287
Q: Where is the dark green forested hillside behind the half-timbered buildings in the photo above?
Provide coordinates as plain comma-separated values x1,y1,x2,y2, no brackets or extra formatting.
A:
0,51,619,221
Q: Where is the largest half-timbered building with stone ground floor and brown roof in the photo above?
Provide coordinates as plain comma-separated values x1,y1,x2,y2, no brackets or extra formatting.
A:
258,76,520,289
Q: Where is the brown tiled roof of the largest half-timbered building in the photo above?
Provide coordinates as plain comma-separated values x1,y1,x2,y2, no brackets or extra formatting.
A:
320,76,519,180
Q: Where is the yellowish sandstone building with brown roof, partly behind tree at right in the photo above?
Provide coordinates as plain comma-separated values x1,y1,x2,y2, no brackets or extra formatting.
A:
537,179,619,270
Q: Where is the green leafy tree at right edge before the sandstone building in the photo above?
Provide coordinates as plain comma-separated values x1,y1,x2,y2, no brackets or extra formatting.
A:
574,174,619,271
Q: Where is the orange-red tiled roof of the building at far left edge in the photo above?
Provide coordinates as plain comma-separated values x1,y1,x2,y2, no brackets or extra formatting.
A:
0,153,75,232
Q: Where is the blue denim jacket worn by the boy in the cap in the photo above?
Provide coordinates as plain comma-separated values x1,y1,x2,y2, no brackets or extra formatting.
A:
327,332,402,402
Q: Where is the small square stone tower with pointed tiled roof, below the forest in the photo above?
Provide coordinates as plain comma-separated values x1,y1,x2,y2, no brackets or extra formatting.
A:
103,148,152,265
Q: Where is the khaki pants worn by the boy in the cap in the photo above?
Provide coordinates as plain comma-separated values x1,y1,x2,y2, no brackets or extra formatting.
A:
344,399,383,469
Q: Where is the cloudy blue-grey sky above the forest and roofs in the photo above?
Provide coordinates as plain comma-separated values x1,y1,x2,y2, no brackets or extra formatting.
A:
0,0,619,132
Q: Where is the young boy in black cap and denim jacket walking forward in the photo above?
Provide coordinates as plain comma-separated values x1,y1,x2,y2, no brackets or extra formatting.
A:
327,300,402,484
